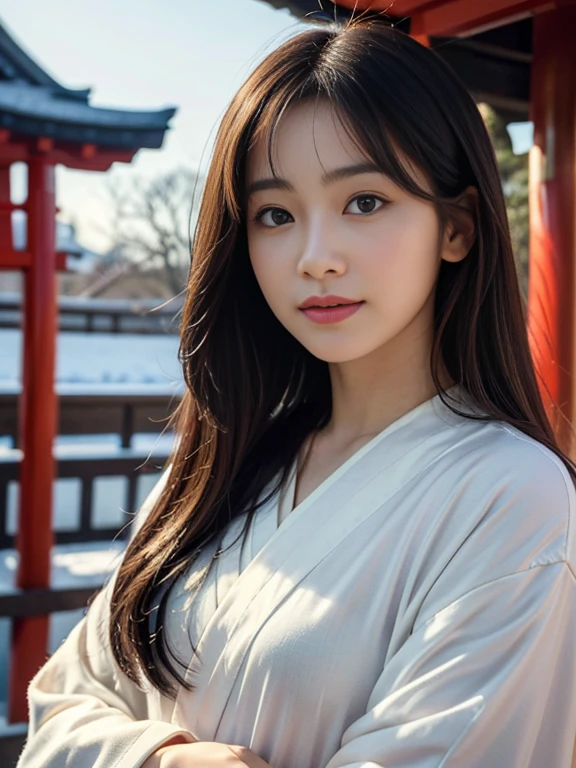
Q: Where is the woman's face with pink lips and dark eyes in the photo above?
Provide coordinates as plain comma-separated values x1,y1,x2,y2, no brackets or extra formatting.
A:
247,103,465,363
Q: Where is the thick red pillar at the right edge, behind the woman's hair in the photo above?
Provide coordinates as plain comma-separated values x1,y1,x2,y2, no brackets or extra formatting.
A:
528,6,576,451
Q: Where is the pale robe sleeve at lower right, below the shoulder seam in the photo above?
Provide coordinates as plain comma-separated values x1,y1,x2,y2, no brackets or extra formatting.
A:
326,562,576,768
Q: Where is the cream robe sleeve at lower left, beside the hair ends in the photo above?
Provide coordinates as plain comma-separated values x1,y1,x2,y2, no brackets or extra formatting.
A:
17,474,195,768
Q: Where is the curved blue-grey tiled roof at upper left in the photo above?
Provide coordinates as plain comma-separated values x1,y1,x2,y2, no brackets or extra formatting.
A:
0,23,176,151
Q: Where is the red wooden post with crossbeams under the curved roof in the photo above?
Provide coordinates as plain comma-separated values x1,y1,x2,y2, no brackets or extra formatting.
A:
0,142,136,723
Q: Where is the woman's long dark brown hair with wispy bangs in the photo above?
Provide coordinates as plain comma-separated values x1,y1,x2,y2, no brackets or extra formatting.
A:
110,19,576,697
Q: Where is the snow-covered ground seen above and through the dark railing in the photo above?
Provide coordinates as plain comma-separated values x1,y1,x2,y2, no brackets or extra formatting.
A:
0,329,183,708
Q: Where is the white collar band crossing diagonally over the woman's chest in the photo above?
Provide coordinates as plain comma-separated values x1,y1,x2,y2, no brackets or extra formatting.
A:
172,385,482,740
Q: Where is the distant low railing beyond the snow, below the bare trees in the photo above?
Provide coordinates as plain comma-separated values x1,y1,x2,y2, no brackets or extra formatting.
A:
0,292,182,333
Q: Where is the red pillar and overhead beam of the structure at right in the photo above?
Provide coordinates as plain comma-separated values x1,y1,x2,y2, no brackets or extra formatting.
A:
264,0,576,458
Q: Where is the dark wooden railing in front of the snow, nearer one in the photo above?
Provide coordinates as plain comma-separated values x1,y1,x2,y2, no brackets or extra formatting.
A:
0,393,178,768
